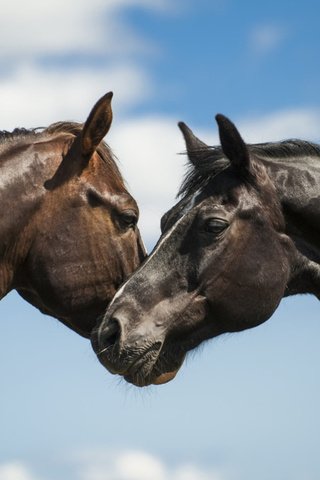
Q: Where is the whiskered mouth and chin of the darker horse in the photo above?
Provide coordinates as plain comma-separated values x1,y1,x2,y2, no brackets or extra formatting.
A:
123,342,185,387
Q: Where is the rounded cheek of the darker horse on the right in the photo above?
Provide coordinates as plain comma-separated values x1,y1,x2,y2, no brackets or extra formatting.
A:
206,242,289,332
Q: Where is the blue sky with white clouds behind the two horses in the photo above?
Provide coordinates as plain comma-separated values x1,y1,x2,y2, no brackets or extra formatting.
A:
0,0,320,480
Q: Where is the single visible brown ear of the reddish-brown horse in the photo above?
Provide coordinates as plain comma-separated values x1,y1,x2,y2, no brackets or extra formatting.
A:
81,92,113,158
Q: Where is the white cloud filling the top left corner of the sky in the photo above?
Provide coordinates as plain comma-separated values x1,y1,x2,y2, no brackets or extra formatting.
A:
0,0,171,60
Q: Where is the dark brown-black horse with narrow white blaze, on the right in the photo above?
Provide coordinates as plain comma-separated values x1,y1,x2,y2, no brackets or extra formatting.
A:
92,114,320,386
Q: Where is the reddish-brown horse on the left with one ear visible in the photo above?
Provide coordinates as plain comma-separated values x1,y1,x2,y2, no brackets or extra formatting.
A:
0,92,145,338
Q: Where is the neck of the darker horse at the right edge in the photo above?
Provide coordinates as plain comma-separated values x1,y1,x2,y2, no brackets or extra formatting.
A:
262,154,320,298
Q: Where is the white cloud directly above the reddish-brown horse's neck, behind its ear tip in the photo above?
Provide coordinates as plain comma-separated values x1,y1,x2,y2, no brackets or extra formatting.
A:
0,63,152,130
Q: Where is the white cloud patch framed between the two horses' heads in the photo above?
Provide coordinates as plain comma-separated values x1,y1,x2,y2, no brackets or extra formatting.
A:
108,117,187,241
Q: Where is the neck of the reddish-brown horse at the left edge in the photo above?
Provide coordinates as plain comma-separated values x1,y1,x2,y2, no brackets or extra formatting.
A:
0,137,58,298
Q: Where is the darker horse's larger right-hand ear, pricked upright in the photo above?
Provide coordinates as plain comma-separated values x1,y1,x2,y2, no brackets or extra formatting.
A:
216,113,250,174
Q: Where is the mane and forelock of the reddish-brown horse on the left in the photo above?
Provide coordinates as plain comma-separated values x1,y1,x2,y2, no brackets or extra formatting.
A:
0,121,124,183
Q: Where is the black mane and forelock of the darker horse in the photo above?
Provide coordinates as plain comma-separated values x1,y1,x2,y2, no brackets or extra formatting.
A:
177,139,320,198
